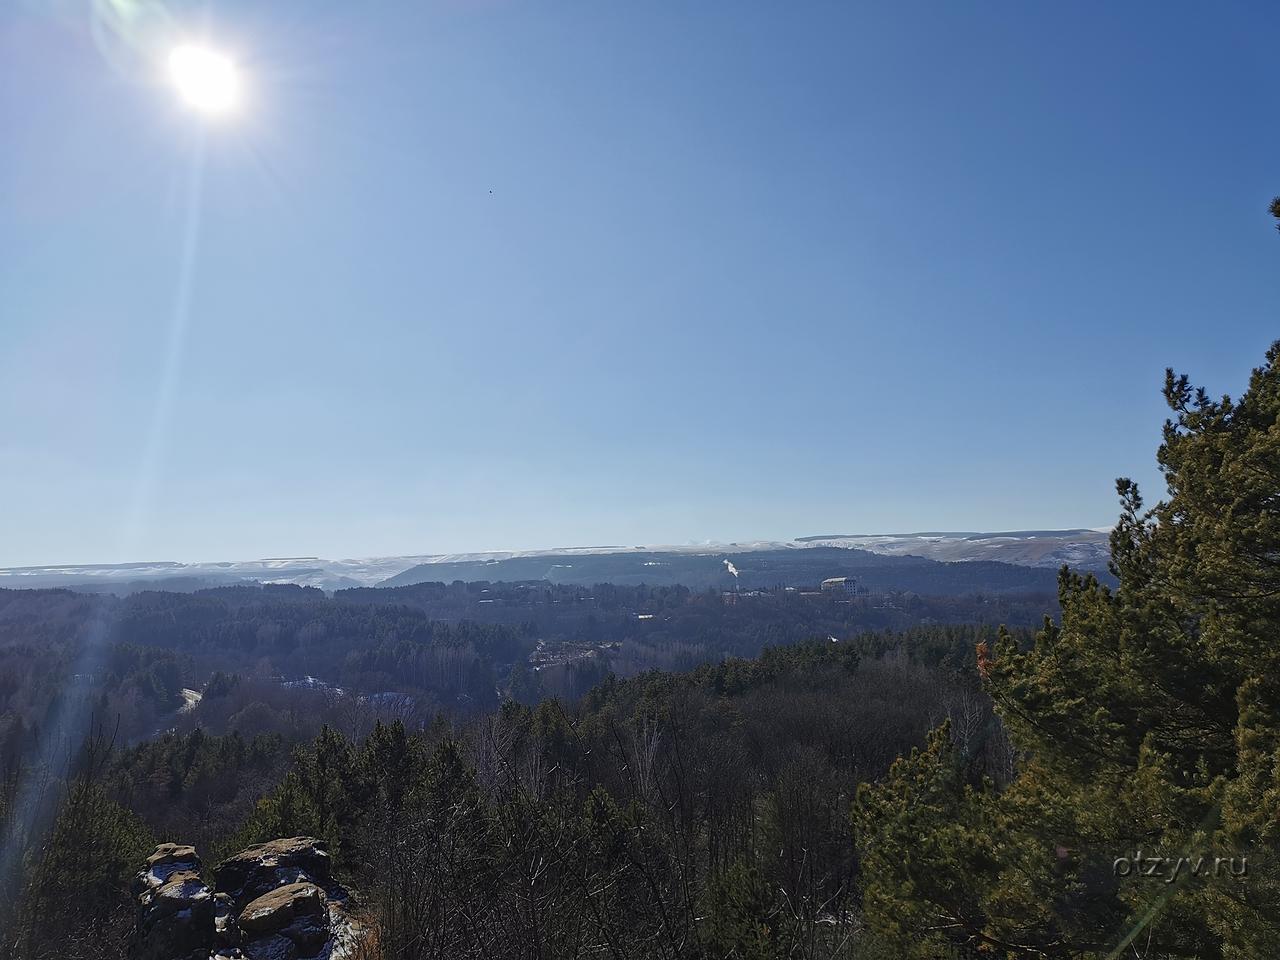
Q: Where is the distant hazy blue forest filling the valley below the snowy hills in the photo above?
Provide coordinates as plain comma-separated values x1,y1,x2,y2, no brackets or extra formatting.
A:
0,564,1056,756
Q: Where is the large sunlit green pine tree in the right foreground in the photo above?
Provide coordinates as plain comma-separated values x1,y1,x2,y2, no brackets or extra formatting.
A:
855,204,1280,960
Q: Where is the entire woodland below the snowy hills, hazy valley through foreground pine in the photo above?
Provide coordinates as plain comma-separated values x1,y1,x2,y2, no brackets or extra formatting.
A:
0,330,1280,960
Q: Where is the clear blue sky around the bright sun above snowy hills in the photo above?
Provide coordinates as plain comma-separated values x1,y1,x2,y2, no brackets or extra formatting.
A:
0,0,1280,566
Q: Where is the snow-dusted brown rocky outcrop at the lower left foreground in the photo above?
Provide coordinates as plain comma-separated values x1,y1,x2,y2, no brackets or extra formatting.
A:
129,837,360,960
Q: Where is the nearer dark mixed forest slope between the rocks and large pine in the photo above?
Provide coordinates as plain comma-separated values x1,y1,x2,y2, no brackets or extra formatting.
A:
12,627,1008,957
